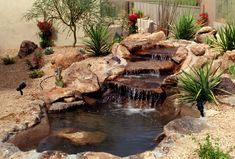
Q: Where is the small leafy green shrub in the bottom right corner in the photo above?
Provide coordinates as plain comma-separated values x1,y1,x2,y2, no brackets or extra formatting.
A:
196,135,232,159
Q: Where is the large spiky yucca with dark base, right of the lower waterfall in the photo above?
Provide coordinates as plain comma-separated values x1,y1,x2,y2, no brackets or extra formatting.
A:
178,62,223,116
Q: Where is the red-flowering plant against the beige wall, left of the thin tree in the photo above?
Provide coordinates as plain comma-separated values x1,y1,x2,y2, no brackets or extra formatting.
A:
37,20,53,48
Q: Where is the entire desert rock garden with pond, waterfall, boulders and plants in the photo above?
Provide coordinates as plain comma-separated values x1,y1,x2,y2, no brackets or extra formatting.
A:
0,0,235,159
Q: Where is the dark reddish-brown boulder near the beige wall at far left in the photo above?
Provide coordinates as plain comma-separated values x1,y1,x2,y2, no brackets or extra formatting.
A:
18,40,38,58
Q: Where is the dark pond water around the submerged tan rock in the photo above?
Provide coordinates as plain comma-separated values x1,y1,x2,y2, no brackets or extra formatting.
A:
37,104,163,156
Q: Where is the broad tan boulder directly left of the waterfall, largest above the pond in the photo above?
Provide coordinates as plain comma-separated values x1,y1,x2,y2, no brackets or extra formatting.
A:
64,55,127,93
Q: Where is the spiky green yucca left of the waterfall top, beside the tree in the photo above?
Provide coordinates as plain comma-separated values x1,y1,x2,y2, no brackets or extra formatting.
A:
84,24,112,56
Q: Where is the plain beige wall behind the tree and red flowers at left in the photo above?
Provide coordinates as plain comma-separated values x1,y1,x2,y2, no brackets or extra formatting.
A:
0,0,82,51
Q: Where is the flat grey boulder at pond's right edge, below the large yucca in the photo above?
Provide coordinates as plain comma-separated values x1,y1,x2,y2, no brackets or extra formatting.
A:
164,116,208,137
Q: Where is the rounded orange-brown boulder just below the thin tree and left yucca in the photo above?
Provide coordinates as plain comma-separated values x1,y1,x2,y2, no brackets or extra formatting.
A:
51,52,84,69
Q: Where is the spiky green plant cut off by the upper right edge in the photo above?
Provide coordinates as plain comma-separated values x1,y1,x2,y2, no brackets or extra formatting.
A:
212,24,235,52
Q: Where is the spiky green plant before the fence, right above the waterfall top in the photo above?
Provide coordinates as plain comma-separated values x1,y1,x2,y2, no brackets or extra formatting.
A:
171,13,199,40
